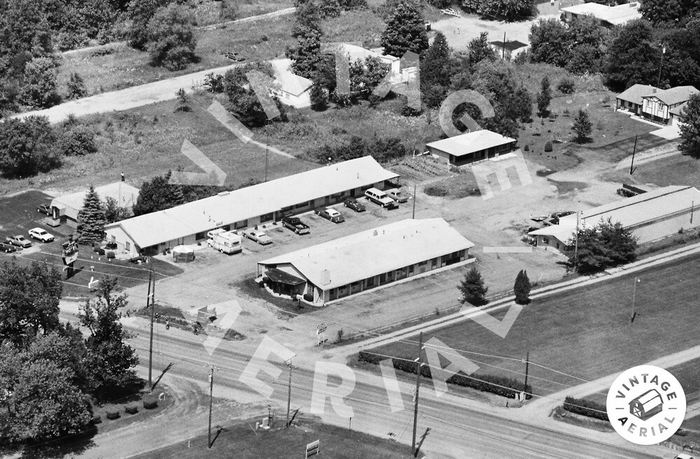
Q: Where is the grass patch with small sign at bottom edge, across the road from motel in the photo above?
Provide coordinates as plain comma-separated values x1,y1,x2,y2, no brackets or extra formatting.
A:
137,420,418,459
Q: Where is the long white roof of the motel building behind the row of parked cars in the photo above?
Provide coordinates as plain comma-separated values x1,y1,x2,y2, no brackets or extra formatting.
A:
105,156,398,248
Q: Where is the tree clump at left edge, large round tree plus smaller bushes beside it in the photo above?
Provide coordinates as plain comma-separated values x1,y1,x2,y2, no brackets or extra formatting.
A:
0,116,97,178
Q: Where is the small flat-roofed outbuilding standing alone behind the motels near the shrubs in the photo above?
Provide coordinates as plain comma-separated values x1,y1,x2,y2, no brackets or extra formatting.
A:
425,129,517,166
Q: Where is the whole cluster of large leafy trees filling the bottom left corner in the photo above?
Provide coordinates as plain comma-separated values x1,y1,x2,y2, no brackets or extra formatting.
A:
0,261,138,444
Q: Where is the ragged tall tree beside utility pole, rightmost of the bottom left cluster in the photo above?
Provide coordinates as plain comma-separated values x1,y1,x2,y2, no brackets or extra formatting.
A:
79,277,139,398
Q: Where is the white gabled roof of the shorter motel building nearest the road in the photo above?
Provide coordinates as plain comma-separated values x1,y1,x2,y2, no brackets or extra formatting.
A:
258,218,474,290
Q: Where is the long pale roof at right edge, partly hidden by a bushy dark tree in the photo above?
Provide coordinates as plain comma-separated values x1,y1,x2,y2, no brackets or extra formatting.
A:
529,185,700,242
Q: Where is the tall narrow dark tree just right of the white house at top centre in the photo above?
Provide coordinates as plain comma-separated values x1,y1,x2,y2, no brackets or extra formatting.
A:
420,32,451,107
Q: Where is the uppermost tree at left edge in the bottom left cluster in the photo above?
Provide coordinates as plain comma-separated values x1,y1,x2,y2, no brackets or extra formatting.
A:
0,260,63,346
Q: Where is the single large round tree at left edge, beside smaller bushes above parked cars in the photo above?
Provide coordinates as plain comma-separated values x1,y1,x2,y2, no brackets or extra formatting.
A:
0,116,61,177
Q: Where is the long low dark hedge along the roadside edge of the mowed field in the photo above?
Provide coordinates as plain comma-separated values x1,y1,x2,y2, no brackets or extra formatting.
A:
359,351,532,399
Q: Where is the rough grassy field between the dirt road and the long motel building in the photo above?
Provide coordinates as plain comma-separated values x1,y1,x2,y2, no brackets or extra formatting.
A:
0,94,318,194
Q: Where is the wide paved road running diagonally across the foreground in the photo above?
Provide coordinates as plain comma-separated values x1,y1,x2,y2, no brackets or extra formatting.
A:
101,325,654,458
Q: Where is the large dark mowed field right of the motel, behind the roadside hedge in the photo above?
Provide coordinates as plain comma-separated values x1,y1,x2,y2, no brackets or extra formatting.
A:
366,256,700,395
